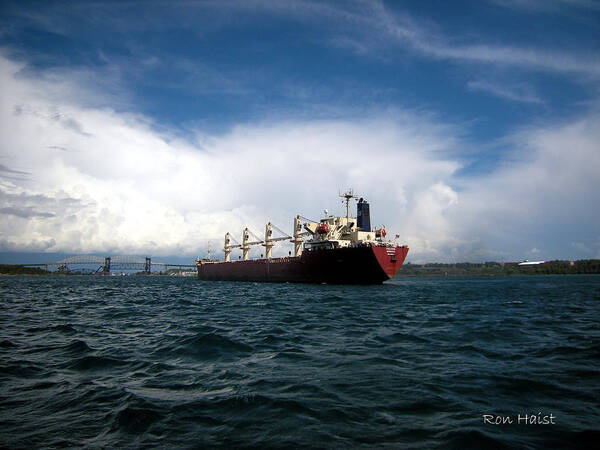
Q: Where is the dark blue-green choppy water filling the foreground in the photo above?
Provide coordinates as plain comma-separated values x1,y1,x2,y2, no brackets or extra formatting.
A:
0,276,600,448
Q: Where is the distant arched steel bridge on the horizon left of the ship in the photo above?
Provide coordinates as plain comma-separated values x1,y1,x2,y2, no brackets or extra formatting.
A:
23,255,196,275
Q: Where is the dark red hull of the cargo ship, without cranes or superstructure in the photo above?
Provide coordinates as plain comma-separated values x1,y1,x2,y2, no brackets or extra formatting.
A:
198,246,408,284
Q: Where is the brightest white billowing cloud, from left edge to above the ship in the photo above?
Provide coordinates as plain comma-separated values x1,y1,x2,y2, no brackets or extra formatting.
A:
0,54,459,255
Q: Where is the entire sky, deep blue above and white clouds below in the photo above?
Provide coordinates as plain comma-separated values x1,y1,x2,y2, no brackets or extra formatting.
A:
0,0,600,263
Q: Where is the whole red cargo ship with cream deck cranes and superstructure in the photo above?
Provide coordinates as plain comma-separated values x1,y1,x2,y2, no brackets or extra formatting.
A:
196,191,408,284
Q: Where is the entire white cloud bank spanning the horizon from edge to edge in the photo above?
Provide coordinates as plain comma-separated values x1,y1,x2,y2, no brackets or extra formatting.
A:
0,56,600,262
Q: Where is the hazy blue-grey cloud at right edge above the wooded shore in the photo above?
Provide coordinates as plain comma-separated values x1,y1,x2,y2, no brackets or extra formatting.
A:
452,114,600,259
